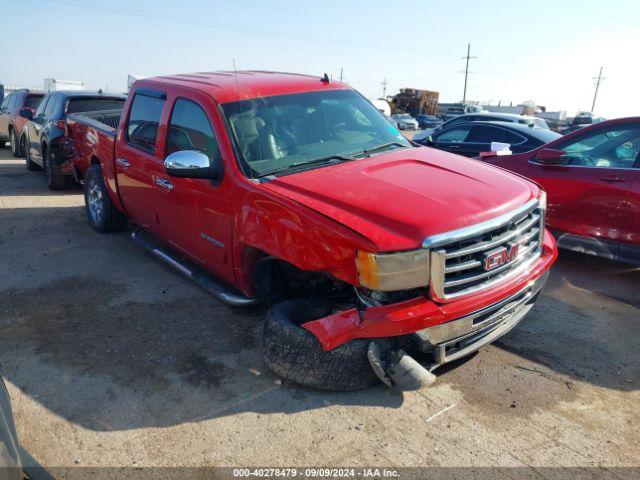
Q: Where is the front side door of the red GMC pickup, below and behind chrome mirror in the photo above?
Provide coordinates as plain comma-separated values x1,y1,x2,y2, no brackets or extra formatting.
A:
153,92,238,282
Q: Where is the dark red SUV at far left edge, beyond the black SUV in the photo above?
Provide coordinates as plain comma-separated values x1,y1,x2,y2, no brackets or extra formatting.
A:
0,89,44,157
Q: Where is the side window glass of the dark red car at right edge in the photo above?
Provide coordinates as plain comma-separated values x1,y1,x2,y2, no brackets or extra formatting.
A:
558,125,640,168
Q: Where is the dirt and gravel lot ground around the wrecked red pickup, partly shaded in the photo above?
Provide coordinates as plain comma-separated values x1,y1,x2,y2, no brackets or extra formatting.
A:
0,149,640,467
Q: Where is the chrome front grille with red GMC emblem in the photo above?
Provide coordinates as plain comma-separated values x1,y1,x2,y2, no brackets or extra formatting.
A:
424,200,544,300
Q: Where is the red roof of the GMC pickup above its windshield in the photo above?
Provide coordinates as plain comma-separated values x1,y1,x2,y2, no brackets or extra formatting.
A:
135,70,351,103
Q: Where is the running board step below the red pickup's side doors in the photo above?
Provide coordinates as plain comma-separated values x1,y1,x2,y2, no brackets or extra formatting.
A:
131,228,258,307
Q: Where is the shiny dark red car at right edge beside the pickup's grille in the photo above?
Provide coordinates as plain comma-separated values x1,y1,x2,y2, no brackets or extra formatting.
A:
479,117,640,263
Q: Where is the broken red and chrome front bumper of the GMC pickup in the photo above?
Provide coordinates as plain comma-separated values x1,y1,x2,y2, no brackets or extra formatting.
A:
302,232,558,354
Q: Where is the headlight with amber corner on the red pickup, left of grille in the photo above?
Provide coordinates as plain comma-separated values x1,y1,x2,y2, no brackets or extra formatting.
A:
356,250,429,292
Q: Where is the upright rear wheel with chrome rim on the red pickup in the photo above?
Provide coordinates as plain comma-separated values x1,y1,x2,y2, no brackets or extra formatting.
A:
84,165,127,233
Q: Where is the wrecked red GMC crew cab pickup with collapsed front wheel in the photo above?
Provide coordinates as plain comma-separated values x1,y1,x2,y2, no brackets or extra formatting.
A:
69,71,557,389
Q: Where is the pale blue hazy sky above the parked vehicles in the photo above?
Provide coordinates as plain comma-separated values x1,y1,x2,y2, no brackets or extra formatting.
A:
0,0,640,118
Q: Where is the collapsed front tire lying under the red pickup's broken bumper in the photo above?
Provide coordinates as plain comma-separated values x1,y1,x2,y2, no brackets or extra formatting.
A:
262,300,384,391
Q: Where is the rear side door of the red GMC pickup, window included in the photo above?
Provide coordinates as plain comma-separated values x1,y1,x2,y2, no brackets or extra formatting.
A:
115,89,166,231
